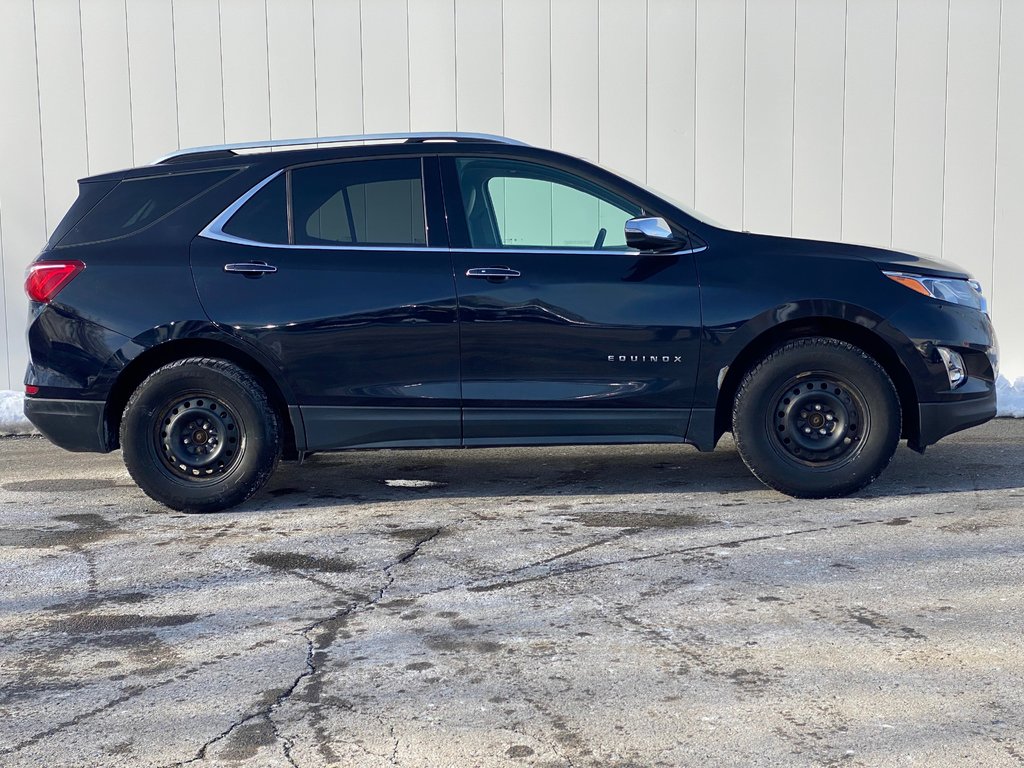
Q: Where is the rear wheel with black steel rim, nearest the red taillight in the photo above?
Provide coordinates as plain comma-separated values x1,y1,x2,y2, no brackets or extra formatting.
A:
121,357,281,512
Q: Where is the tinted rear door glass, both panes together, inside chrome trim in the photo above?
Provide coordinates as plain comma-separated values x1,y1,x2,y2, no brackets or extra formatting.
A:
221,158,427,247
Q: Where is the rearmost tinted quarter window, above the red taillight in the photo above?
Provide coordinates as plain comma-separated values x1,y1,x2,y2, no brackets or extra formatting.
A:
60,169,237,247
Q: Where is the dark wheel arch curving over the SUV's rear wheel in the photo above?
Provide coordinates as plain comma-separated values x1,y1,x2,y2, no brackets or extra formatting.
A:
104,338,305,459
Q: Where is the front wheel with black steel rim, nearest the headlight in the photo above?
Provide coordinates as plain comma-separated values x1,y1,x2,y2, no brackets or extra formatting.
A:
732,337,902,499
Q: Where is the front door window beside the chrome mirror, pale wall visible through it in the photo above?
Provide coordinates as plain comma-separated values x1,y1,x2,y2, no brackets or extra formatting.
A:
456,158,643,251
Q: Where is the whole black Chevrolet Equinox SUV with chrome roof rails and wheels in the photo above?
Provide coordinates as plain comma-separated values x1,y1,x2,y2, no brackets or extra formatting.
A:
26,133,997,512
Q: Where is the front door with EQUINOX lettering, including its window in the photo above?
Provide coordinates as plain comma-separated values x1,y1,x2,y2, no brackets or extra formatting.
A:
441,156,700,445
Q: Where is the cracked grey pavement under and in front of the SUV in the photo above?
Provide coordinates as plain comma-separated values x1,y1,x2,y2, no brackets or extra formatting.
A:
0,420,1024,768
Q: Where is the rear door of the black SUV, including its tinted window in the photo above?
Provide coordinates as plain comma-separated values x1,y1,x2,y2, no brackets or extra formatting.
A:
191,156,461,450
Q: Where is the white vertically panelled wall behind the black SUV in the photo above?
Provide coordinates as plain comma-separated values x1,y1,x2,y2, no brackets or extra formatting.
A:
0,0,1024,388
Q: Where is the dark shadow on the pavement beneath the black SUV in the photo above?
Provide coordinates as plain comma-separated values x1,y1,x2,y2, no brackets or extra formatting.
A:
254,420,1024,507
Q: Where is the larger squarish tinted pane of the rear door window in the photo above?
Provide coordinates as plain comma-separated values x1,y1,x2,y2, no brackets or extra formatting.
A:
291,158,427,246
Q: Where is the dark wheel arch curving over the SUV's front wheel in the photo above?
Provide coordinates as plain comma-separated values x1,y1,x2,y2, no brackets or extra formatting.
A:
715,316,921,442
